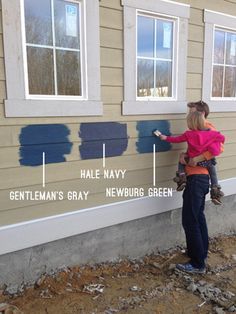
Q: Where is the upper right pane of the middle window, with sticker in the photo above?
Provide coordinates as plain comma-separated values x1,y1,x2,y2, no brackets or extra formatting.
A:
156,20,173,59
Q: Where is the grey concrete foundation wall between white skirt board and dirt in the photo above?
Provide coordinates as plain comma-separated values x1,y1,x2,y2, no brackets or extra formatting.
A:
0,195,236,293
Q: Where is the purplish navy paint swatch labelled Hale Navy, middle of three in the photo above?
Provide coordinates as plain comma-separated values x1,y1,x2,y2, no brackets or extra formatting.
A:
79,122,128,159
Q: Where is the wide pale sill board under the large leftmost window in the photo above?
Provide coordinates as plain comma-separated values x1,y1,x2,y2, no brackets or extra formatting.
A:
5,99,103,117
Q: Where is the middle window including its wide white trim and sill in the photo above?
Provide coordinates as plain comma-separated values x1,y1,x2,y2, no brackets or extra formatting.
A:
122,0,189,115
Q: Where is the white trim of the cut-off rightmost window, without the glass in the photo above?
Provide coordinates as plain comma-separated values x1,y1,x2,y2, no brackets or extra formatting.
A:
202,10,236,112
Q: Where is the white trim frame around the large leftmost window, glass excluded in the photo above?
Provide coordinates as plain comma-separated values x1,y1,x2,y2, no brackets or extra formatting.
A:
2,0,103,117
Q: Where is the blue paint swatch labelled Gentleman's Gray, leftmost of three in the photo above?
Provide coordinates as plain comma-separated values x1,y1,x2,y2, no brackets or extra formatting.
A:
19,124,72,166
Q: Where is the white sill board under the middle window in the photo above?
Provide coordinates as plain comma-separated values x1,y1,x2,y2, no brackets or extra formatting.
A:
122,100,187,115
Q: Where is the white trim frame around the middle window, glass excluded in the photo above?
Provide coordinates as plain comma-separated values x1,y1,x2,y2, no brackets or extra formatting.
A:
122,0,190,115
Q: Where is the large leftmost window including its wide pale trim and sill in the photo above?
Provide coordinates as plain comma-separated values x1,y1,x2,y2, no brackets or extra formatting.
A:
2,0,102,117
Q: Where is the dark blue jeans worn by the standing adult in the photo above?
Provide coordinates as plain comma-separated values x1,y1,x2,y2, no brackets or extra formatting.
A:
182,174,209,268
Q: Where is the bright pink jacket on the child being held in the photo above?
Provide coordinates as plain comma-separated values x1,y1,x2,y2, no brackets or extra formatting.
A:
166,130,225,158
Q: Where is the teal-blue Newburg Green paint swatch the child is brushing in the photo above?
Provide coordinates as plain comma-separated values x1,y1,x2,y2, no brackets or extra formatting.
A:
136,120,171,154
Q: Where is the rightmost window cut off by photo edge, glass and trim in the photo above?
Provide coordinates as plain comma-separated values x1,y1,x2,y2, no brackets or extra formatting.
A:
203,10,236,112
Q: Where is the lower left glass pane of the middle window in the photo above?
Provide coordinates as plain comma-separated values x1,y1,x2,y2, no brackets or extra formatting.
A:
137,60,154,97
